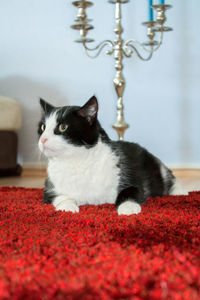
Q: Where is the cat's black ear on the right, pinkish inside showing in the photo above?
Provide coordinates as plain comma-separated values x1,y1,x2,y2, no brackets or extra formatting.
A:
78,96,98,125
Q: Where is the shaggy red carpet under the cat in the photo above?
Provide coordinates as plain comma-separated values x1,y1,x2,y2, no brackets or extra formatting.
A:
0,188,200,300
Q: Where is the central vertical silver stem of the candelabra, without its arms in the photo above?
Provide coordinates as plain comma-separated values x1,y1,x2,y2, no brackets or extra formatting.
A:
113,1,129,140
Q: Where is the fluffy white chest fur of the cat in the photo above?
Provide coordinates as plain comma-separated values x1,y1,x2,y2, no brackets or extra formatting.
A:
48,141,120,205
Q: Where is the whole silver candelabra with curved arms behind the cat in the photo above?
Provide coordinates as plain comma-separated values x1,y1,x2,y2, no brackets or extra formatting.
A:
72,0,172,140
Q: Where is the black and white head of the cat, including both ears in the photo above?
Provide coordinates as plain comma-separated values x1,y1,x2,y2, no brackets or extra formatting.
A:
38,96,101,158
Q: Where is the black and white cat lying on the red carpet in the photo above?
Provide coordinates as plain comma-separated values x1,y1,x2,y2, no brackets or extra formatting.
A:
38,96,186,215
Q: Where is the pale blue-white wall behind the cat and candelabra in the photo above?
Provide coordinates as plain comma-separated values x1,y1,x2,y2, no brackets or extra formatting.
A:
0,0,200,166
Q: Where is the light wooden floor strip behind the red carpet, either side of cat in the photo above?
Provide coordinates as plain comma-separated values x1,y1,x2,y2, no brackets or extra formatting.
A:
0,170,200,191
